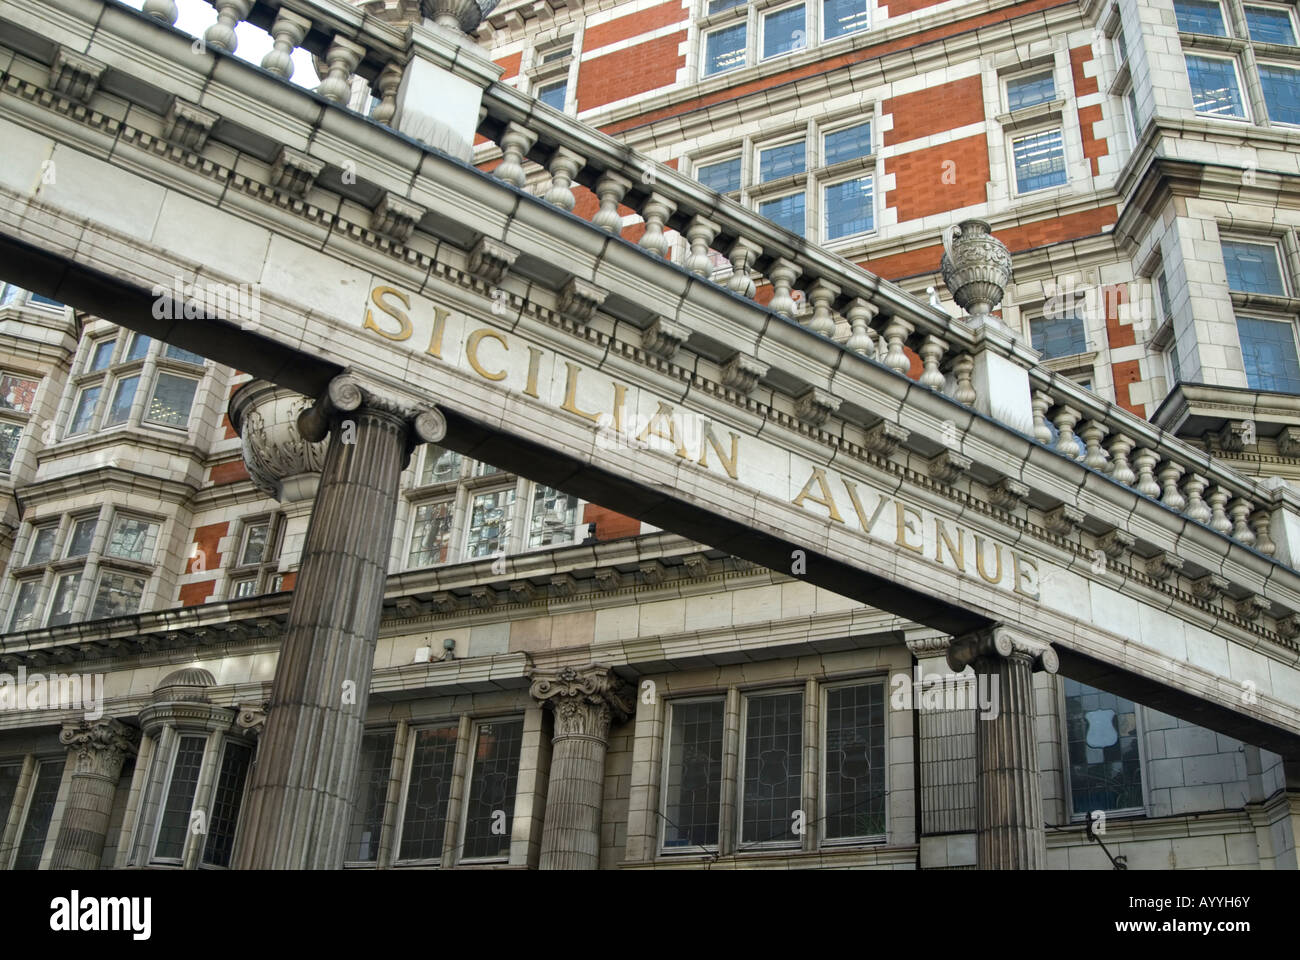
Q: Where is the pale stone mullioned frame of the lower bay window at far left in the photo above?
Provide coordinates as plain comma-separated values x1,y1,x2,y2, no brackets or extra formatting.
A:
0,503,176,631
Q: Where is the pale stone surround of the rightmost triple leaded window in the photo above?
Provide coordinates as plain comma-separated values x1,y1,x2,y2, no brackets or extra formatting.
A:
655,670,889,859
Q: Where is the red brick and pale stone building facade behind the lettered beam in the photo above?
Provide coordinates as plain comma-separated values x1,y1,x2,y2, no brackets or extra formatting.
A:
0,0,1300,869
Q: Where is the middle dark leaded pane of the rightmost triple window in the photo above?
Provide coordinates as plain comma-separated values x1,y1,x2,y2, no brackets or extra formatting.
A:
740,693,803,843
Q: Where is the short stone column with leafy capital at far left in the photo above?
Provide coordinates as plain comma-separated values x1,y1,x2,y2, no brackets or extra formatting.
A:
49,717,137,870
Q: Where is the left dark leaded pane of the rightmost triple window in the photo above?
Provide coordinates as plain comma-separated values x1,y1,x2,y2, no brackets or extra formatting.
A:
663,700,723,849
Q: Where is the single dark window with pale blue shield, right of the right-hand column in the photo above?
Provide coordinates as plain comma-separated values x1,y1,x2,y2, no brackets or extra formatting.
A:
1065,679,1143,813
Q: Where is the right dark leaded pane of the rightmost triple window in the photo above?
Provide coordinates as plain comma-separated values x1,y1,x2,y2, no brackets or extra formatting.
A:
824,683,885,840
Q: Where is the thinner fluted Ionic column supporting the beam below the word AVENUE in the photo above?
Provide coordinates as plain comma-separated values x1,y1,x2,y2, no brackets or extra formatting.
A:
948,626,1058,870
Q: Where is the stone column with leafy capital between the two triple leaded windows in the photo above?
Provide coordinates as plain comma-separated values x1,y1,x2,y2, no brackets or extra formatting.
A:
530,663,632,870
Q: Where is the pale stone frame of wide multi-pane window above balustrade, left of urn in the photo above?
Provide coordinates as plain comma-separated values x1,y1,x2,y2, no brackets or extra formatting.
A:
689,105,883,251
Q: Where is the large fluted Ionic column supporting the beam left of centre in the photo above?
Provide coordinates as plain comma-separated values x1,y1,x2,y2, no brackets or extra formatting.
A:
238,375,446,869
